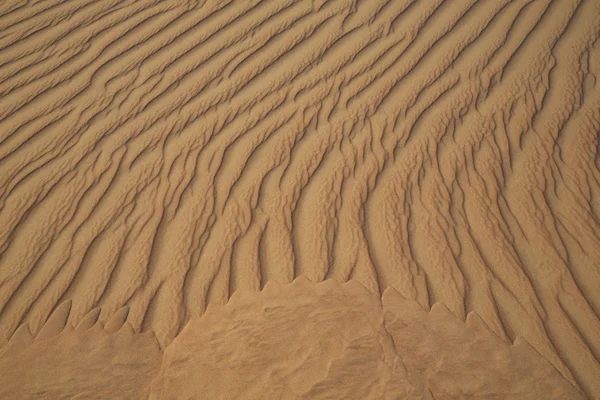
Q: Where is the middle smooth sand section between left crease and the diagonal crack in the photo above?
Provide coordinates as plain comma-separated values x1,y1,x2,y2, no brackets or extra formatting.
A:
150,280,431,399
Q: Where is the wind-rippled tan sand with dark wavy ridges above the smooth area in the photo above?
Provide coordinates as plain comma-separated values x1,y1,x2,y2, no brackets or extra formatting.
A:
0,0,600,397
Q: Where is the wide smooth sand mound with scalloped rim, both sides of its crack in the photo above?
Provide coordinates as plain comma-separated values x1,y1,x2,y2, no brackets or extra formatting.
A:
150,279,583,399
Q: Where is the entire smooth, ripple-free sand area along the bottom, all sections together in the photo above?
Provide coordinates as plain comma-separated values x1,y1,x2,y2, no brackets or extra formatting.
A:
0,277,584,400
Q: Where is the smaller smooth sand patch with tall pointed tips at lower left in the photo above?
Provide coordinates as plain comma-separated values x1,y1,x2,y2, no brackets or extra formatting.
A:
0,303,162,400
